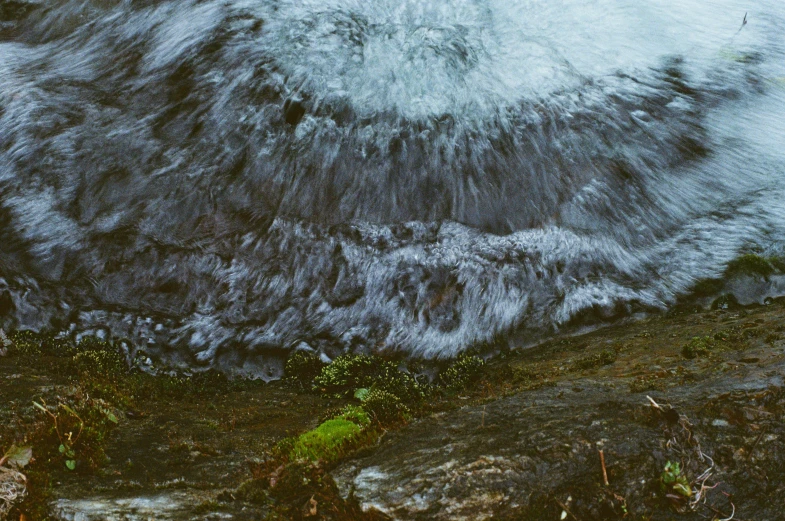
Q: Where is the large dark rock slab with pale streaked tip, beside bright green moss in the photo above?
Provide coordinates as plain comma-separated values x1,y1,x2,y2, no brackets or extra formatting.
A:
334,308,785,520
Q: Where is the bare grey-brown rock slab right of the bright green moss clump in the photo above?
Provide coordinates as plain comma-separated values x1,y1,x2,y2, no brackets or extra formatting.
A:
334,361,785,520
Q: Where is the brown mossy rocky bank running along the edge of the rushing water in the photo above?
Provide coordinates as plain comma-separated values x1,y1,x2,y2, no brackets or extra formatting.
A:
0,301,785,521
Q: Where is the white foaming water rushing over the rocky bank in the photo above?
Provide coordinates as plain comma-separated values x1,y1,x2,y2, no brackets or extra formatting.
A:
0,0,785,376
